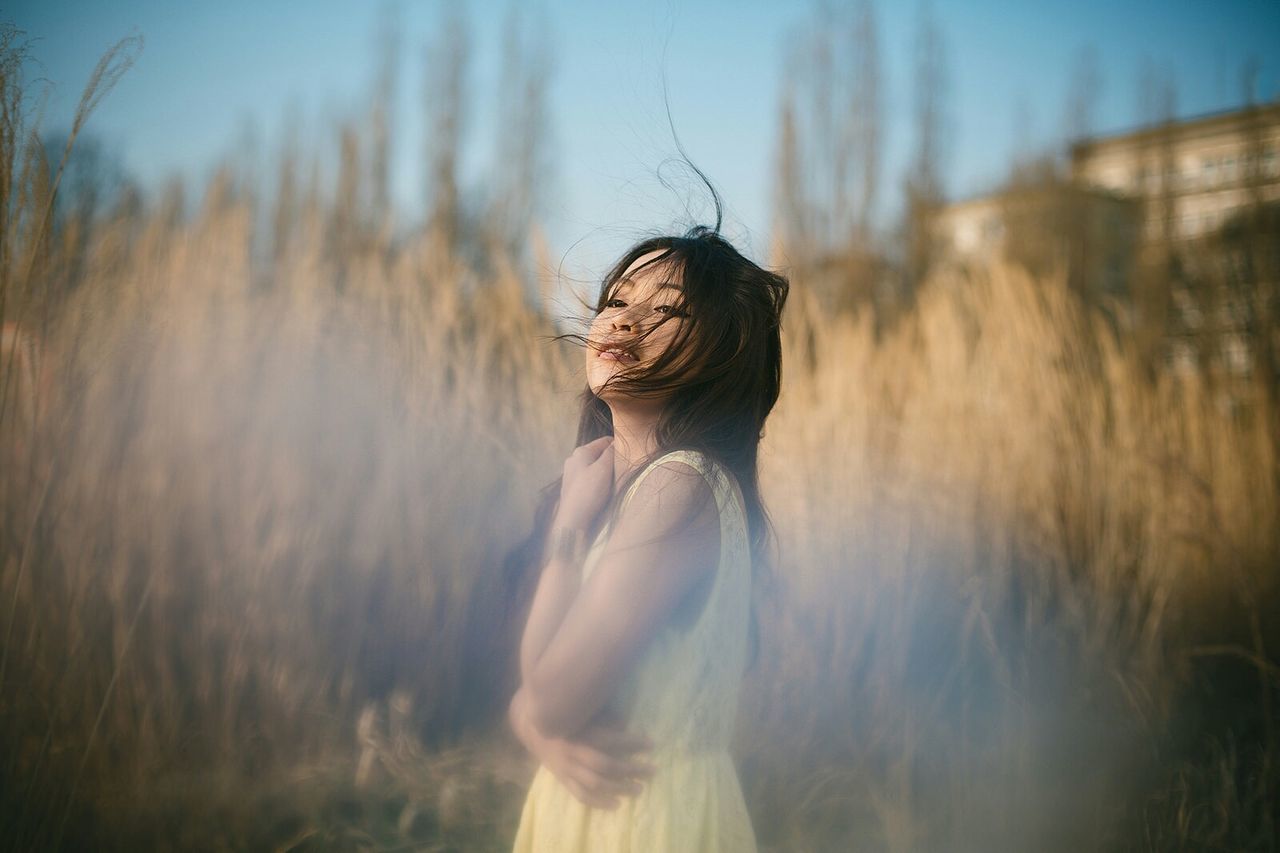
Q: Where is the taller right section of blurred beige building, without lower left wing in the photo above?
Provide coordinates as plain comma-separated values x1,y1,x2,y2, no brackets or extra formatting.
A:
1071,104,1280,383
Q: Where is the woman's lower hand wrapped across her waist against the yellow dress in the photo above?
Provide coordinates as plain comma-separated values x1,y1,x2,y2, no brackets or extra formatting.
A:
509,688,654,809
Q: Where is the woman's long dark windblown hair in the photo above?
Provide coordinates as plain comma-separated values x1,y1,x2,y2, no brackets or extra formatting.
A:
507,220,788,662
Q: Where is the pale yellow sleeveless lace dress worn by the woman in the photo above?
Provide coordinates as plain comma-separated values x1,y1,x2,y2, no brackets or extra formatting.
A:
515,451,756,853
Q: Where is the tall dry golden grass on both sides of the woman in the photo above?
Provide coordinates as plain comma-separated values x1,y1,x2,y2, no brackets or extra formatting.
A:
0,23,1280,850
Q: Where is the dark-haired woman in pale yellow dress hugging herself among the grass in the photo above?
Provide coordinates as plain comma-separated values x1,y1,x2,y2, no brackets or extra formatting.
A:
509,222,787,853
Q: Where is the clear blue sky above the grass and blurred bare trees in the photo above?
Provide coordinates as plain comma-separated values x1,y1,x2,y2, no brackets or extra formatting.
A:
10,0,1280,268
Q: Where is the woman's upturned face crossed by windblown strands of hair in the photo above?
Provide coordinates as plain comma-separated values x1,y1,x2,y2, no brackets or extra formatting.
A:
586,250,687,400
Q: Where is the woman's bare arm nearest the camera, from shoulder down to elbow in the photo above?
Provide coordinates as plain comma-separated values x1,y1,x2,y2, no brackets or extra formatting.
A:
521,461,719,736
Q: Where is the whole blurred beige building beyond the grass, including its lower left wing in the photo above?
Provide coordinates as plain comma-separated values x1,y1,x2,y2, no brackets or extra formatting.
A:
936,104,1280,383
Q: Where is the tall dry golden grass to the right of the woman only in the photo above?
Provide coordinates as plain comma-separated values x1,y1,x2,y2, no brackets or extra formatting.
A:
745,264,1280,850
